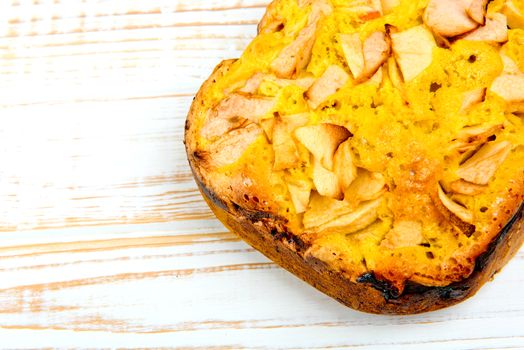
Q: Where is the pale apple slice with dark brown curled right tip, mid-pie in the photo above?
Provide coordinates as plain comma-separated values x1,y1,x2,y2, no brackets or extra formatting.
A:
295,123,351,170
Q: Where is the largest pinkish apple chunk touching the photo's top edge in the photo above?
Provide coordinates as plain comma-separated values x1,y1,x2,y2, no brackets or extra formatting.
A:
424,0,479,38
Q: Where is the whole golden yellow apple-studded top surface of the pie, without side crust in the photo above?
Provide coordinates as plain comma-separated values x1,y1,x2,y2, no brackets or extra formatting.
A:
186,0,524,292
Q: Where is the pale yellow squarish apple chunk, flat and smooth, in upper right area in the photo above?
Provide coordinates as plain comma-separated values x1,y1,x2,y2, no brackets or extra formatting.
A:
391,26,437,82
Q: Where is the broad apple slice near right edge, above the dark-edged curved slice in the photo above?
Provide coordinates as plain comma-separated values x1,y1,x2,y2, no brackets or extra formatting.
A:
456,141,512,185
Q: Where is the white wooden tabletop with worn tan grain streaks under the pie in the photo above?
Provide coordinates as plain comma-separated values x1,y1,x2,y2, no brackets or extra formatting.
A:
0,0,524,350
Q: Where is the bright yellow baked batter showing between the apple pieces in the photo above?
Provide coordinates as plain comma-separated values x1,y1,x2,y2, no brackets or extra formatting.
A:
196,0,524,285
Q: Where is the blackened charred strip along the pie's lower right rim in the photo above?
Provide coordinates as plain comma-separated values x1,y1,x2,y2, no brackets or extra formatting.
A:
357,204,524,302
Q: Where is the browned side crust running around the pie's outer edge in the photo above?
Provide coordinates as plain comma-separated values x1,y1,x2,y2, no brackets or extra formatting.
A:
184,60,524,315
